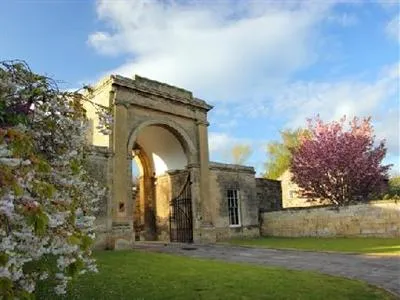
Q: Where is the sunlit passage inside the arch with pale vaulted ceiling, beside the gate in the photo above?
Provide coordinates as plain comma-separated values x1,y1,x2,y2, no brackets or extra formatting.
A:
128,120,194,241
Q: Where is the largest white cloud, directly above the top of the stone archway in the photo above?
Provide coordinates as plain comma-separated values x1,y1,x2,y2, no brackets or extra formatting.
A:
88,0,331,101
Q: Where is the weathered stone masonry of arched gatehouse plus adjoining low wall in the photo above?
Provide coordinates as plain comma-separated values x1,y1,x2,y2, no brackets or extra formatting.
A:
87,76,400,245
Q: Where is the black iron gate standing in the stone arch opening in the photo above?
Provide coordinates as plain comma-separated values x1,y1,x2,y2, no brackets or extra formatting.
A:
169,174,193,243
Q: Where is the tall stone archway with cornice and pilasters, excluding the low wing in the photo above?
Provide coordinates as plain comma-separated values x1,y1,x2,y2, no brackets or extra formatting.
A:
83,75,215,248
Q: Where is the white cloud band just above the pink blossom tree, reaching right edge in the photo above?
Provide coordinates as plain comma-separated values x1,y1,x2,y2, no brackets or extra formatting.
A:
275,64,400,155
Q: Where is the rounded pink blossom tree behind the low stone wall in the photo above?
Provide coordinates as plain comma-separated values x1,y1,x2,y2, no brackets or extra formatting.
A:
290,117,390,205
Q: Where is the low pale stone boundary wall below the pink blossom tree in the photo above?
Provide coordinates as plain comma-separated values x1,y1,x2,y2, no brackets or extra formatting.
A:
261,200,400,237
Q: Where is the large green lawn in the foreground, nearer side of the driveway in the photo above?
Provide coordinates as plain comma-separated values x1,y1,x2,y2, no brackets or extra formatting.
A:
37,251,395,300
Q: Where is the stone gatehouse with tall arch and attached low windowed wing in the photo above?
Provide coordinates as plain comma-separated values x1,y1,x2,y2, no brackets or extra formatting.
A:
87,75,281,248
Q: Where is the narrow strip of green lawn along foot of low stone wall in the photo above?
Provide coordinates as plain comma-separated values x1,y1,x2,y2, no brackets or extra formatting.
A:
230,237,400,255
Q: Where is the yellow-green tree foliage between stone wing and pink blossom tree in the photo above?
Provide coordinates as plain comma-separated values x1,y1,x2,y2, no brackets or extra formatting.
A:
264,128,308,179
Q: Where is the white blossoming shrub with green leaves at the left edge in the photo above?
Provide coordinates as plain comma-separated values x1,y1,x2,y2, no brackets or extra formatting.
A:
0,61,112,299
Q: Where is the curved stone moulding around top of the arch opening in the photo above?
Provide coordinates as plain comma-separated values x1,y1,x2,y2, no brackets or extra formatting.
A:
127,119,197,164
